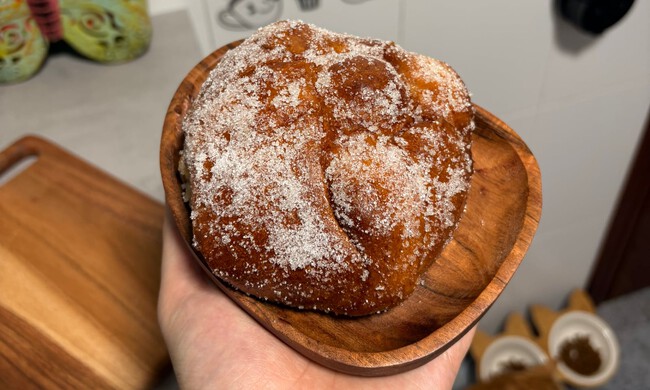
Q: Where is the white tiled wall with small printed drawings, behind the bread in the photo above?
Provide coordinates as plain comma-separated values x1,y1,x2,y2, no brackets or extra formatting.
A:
177,0,650,330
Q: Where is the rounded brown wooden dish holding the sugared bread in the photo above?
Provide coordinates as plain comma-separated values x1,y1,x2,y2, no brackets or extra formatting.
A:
160,42,542,376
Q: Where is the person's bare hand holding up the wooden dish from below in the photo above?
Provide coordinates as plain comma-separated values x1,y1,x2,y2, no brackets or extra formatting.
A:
158,218,475,389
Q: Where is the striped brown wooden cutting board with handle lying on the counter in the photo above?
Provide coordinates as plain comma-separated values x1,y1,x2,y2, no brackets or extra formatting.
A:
0,137,169,389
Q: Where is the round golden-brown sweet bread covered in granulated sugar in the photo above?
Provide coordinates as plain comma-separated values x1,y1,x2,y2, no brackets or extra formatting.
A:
182,21,474,315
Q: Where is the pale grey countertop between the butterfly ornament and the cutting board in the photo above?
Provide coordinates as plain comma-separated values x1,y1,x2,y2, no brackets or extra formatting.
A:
0,11,201,201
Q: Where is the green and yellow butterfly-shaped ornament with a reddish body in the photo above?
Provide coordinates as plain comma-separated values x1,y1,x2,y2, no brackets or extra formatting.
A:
0,0,152,84
